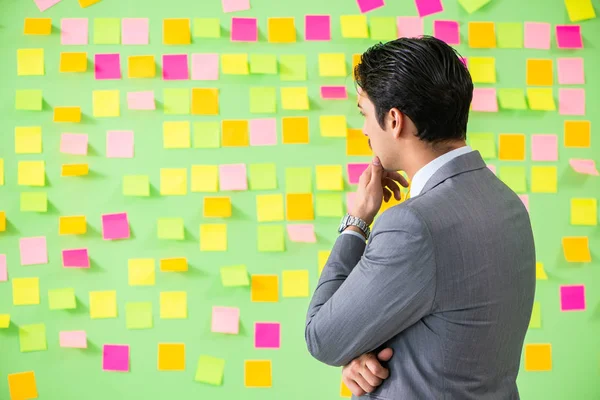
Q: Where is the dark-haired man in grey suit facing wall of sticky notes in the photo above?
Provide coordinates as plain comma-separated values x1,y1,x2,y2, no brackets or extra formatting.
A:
305,37,535,400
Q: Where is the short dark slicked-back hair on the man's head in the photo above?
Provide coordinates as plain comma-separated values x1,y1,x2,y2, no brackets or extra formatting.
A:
354,36,473,143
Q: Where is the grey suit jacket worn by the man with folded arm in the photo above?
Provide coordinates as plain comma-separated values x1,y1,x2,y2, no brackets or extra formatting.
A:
305,151,535,400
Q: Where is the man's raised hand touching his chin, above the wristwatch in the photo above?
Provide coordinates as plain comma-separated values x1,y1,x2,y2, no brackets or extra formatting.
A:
352,157,408,225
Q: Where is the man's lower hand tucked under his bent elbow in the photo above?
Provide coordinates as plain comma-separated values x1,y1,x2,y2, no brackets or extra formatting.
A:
342,348,394,397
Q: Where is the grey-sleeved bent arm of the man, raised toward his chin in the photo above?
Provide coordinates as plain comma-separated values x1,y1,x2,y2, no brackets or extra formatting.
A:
305,206,435,366
